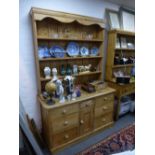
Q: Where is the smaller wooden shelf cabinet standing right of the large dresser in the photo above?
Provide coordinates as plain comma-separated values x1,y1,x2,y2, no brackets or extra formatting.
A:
106,29,135,120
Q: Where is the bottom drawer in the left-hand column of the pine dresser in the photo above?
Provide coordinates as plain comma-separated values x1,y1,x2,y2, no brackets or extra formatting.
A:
52,128,78,147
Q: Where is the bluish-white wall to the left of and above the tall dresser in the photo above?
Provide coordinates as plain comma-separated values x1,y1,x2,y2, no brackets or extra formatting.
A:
19,0,119,128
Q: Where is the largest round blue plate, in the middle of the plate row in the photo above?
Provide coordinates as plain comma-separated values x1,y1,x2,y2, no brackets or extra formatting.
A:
67,42,79,57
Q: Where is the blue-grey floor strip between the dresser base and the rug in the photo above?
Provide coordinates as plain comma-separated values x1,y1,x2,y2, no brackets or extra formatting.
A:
56,113,135,155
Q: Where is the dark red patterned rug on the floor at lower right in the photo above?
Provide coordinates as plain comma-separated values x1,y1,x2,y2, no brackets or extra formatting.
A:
77,124,135,155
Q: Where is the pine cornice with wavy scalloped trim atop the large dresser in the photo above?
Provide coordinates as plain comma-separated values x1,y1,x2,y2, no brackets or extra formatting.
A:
30,8,105,28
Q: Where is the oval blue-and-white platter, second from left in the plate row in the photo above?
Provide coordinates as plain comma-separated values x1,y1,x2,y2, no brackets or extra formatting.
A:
50,45,65,58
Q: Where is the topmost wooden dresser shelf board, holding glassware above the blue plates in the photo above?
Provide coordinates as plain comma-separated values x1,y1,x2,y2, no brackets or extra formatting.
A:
37,37,103,42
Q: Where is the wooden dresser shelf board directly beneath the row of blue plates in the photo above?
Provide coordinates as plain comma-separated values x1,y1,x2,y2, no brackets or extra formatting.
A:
39,56,102,61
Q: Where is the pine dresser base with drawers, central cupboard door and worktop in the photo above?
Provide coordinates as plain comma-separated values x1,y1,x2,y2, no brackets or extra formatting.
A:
38,87,115,153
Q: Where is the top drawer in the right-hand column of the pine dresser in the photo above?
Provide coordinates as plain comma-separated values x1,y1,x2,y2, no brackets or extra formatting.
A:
95,94,114,108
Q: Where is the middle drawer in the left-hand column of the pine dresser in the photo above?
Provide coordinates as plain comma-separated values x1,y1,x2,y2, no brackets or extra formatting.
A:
50,113,79,133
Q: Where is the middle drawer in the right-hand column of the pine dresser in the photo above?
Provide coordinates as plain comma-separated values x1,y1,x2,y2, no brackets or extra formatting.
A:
95,101,114,117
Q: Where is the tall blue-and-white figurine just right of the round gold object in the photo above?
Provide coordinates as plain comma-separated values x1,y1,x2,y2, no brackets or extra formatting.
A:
56,80,65,103
